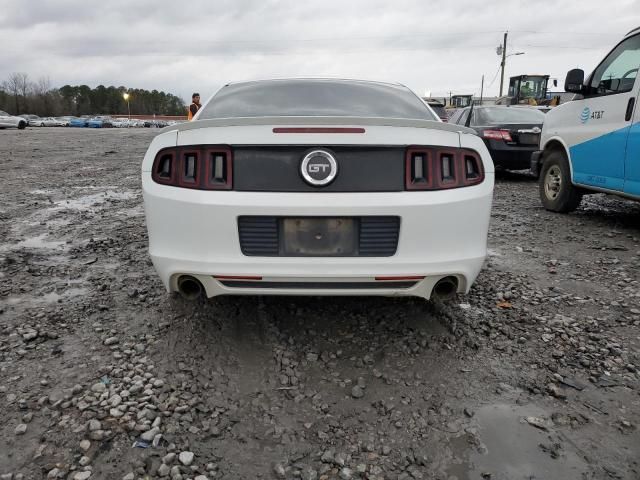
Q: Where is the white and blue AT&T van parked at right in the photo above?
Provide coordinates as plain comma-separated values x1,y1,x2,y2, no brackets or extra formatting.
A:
531,27,640,212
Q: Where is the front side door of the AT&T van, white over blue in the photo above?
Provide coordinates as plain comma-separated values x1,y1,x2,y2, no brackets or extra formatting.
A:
569,34,640,191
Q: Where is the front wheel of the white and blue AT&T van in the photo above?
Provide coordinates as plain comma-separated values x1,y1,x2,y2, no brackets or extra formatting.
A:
538,150,582,213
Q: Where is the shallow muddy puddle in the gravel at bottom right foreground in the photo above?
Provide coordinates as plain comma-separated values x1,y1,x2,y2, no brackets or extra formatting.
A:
448,405,588,480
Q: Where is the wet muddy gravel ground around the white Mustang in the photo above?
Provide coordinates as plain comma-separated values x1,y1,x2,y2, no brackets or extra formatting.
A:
0,128,640,480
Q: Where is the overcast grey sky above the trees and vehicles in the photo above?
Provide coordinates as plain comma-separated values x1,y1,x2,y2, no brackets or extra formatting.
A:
0,0,640,101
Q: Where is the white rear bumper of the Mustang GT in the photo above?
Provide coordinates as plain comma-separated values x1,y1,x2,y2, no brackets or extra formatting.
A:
143,172,493,298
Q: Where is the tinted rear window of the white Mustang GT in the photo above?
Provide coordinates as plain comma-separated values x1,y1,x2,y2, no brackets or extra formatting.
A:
198,80,436,120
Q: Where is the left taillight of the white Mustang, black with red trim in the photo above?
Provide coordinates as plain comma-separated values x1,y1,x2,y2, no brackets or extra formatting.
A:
151,145,233,190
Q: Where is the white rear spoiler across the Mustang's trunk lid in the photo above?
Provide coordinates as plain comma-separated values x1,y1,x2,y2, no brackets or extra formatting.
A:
159,117,475,134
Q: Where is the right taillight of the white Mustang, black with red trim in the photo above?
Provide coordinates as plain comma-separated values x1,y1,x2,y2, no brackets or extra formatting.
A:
405,147,484,190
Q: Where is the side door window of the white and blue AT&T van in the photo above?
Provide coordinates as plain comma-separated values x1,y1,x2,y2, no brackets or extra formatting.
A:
590,35,640,95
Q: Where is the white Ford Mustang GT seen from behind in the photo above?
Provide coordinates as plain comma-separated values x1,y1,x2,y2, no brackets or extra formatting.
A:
142,79,494,299
